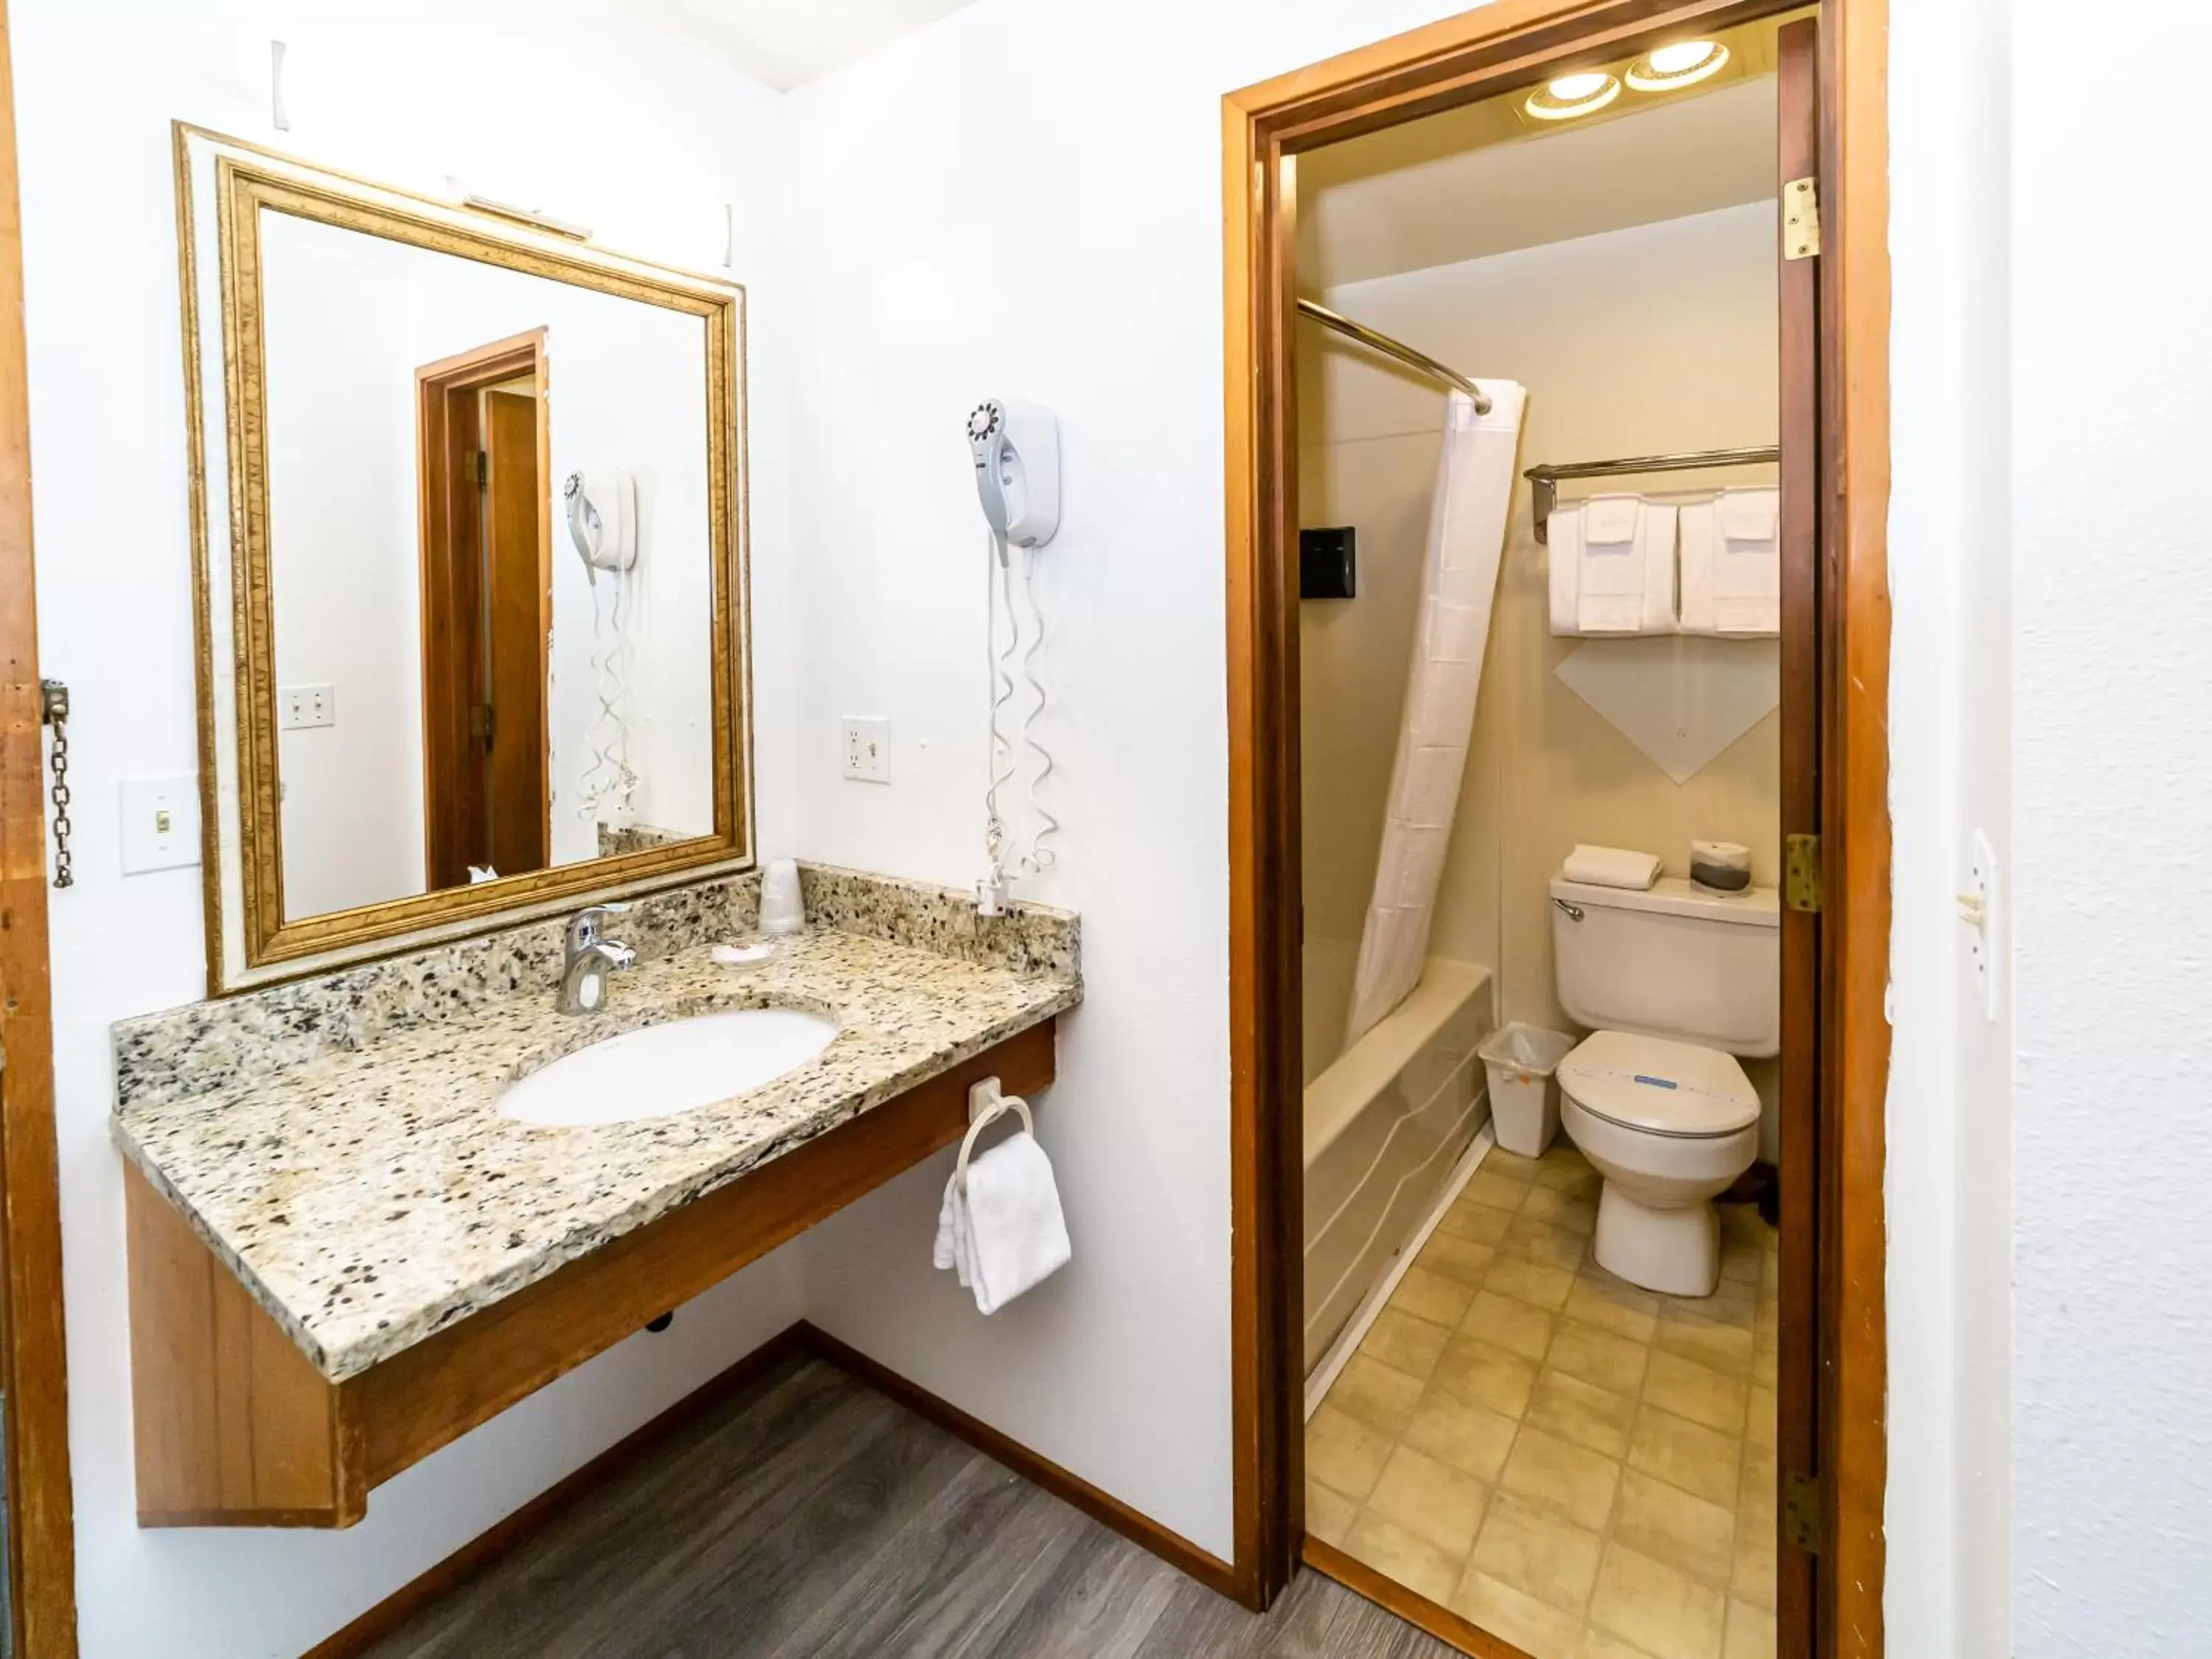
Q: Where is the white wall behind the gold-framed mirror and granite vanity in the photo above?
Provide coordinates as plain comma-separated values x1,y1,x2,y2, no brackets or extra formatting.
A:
9,0,796,1659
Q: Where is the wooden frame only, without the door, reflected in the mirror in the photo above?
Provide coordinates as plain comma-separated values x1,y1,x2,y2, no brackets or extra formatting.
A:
416,327,553,889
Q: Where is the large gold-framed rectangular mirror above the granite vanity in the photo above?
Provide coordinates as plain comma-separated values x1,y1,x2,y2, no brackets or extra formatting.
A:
175,122,754,995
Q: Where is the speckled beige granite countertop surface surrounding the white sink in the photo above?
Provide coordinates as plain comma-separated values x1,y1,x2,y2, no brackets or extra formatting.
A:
113,872,1082,1382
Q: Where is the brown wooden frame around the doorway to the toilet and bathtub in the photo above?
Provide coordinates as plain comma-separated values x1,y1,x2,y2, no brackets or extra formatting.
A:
1221,0,1889,1659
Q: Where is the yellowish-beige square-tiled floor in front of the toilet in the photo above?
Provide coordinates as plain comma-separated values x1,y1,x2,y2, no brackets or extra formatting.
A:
1305,1137,1778,1659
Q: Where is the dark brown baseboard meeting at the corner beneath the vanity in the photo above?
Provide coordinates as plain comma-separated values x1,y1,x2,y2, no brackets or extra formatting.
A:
301,1321,1248,1659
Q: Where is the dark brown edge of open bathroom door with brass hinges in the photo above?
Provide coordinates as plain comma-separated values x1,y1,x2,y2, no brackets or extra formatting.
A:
1774,18,1827,1659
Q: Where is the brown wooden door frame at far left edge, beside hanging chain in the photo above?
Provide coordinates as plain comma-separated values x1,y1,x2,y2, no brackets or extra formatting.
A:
0,0,77,1659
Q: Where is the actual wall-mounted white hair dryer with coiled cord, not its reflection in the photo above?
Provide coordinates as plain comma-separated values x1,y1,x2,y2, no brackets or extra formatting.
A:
969,398,1060,916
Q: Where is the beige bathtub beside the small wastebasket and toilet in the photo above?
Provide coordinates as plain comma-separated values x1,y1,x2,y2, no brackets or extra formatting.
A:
1305,960,1491,1371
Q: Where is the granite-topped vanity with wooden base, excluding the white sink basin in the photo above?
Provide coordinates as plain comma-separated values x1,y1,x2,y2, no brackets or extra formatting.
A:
113,867,1082,1526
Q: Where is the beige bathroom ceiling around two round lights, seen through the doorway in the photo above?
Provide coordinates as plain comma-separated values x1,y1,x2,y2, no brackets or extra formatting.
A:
1298,22,1774,290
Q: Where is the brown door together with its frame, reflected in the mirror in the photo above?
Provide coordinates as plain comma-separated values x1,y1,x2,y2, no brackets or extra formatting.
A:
416,330,553,889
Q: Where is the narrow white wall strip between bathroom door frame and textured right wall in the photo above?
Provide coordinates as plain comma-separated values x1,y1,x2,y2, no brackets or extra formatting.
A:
1885,0,2017,1659
